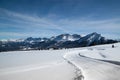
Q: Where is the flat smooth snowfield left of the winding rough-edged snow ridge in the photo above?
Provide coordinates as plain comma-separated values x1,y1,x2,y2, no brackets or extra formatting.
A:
0,50,75,80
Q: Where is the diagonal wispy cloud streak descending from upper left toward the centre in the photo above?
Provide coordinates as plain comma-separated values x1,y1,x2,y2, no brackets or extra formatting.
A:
0,8,66,32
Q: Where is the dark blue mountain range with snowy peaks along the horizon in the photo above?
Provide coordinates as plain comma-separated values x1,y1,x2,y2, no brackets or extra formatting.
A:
0,32,118,51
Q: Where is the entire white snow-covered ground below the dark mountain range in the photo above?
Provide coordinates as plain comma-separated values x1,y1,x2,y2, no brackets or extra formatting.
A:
0,43,120,80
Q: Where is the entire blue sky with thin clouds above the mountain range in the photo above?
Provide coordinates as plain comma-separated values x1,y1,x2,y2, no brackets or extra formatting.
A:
0,0,120,39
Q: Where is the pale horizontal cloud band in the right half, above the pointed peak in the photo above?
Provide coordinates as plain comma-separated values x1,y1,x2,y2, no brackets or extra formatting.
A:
55,18,120,32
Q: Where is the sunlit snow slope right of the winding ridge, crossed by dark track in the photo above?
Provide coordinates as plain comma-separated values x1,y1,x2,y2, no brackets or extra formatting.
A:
64,43,120,80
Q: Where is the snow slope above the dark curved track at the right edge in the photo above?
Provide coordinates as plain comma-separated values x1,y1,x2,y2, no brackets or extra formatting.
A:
80,43,120,61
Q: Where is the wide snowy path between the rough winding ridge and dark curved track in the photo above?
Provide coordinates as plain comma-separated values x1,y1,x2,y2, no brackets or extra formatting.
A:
63,51,120,80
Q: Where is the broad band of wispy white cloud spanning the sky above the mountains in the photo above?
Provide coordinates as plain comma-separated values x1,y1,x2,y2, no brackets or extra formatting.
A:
0,8,120,37
